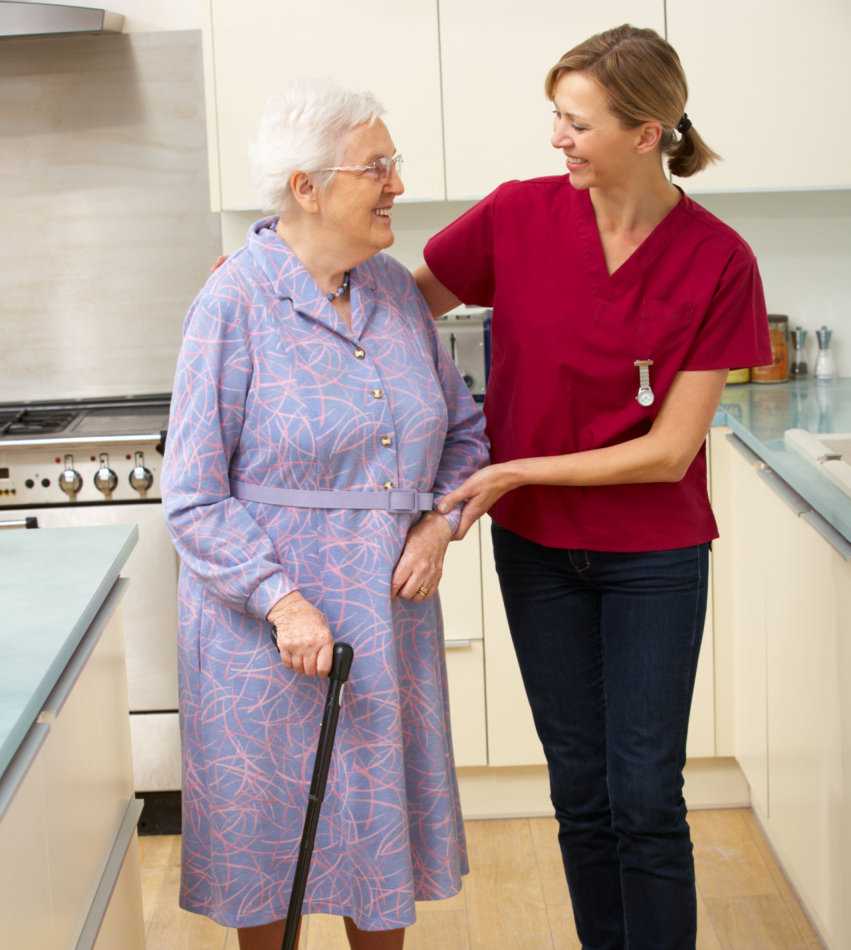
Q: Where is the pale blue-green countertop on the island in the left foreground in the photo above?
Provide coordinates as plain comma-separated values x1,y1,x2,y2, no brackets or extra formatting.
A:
0,525,139,775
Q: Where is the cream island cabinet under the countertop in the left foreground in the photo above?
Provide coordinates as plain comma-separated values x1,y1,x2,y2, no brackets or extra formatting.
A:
0,581,145,950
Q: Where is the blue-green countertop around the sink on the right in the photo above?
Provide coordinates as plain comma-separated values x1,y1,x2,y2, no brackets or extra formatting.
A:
713,378,851,543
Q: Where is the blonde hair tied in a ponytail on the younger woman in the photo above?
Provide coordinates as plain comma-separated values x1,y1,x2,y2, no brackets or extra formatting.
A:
545,23,721,178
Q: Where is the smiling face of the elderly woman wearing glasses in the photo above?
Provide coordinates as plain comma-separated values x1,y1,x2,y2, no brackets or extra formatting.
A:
320,119,405,260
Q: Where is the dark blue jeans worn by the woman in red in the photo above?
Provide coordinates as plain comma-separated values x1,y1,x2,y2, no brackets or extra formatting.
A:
493,525,709,950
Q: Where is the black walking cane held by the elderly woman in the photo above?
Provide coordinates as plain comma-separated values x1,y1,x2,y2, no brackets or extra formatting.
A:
272,627,354,950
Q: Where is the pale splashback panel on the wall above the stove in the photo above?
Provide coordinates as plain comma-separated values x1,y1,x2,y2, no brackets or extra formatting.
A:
0,30,221,401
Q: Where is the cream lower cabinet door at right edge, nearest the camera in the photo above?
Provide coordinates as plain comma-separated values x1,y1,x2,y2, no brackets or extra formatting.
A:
763,487,851,947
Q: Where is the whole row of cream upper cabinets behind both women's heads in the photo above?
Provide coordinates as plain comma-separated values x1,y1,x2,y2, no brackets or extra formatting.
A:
205,0,851,211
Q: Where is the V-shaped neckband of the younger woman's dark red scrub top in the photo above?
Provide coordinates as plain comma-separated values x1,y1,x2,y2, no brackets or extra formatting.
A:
574,189,687,301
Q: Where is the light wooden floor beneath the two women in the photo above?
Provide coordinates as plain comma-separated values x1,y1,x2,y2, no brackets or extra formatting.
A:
139,809,822,950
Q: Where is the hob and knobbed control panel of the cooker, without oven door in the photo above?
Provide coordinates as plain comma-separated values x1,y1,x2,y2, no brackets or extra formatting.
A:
0,393,170,508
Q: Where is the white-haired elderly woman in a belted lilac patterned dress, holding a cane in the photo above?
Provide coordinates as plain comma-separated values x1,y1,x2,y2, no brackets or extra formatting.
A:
163,81,487,950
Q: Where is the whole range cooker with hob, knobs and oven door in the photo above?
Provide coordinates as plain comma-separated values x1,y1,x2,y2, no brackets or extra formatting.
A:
0,394,180,792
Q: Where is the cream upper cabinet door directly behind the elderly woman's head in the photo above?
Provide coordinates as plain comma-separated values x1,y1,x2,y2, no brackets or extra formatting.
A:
205,0,444,211
